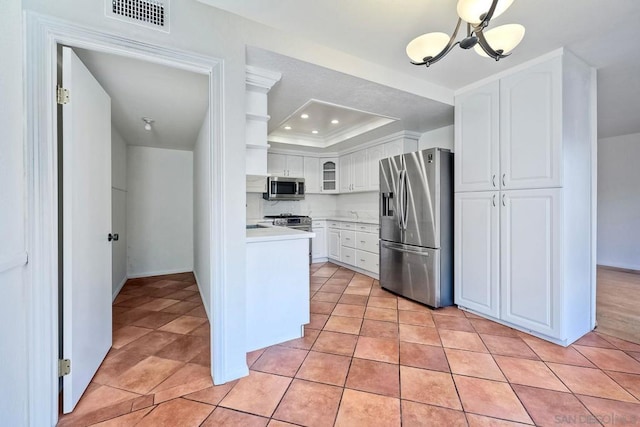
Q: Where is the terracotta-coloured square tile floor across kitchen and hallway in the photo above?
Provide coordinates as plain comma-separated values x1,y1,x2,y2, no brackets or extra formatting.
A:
59,263,640,427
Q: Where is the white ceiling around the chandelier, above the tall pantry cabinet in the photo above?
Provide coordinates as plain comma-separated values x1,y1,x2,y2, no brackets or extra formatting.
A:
199,0,640,137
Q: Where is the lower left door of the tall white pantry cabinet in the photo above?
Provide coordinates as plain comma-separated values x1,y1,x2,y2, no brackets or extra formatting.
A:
453,191,500,318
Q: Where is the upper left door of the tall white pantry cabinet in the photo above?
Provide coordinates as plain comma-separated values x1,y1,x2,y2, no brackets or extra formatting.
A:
453,81,500,192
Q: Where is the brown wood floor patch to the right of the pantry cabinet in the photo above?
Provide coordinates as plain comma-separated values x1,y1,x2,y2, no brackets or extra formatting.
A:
596,266,640,343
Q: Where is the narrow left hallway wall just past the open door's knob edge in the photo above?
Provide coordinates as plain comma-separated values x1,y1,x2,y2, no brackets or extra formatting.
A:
111,126,127,299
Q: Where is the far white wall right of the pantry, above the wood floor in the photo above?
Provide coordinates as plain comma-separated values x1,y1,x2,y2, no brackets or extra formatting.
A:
598,133,640,270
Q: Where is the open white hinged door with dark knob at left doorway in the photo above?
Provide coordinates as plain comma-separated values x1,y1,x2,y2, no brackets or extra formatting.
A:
62,47,111,413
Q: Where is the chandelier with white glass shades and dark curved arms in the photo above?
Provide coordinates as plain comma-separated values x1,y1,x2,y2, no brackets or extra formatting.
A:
407,0,524,67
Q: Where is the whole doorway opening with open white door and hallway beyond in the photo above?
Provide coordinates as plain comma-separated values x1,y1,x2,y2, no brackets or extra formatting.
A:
58,46,211,416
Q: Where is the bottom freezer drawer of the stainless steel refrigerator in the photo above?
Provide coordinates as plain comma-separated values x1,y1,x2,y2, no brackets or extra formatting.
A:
380,240,453,308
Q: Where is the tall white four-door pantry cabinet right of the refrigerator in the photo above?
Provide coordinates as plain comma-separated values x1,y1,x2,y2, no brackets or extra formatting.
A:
454,50,596,345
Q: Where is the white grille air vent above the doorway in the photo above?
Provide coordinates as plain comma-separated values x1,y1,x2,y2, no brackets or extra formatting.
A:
106,0,169,33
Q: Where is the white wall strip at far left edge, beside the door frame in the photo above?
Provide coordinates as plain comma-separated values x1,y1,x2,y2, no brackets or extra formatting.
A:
0,0,29,426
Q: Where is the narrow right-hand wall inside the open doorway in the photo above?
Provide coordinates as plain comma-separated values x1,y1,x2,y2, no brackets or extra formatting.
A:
193,113,211,319
